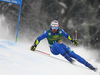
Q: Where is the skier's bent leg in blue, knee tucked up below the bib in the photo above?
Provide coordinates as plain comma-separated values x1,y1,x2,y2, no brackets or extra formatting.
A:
51,42,73,63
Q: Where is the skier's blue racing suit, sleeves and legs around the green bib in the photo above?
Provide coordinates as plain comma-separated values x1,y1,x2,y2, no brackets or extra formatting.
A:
37,29,92,68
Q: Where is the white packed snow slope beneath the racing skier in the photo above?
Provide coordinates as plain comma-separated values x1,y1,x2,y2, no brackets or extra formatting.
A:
0,40,100,75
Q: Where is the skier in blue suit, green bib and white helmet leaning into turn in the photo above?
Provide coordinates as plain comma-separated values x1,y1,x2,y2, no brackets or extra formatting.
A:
31,20,97,71
